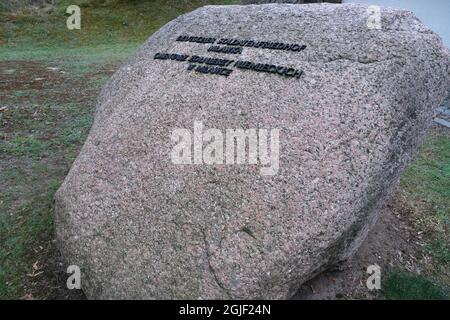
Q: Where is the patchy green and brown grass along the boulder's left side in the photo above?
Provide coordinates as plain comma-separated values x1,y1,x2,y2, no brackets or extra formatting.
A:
0,52,128,299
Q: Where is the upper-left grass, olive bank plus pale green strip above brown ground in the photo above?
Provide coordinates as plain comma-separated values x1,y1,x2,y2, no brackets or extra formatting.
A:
0,0,240,63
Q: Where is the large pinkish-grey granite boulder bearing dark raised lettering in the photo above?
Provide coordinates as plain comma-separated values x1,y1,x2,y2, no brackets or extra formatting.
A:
55,4,449,299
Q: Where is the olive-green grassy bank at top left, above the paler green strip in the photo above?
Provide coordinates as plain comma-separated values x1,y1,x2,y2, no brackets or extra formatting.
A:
0,0,239,47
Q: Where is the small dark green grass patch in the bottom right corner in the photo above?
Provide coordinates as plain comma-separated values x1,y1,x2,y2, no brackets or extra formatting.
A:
383,271,448,300
